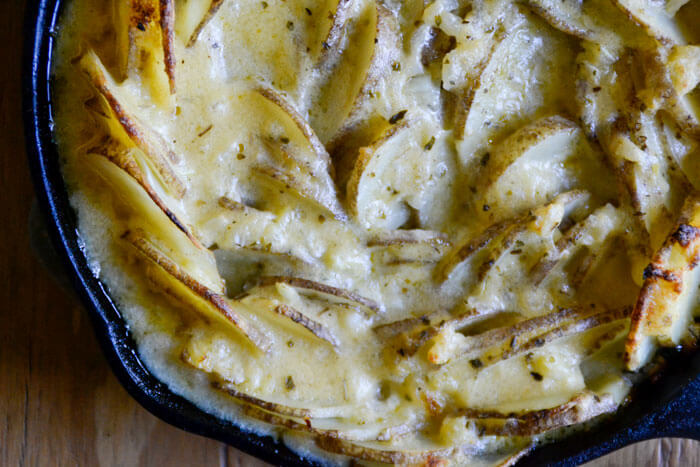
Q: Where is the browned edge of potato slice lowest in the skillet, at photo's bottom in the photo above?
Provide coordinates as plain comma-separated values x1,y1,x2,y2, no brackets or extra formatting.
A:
316,437,454,465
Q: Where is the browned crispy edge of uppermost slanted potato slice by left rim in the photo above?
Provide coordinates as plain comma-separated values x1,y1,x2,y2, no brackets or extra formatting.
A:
83,51,187,199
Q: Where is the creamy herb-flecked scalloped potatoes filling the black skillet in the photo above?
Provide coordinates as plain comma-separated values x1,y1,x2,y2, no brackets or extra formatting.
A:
55,0,700,465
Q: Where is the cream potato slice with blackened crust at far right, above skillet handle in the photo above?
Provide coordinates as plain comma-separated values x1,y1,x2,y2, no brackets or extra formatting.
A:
625,195,700,371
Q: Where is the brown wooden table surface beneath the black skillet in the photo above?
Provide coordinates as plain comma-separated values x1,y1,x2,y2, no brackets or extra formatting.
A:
0,0,700,467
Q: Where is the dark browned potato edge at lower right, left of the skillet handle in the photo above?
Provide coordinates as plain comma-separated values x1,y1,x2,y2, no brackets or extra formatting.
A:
456,393,618,436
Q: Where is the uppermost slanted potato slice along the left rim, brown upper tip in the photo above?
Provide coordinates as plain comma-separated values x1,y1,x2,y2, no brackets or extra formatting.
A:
80,50,186,199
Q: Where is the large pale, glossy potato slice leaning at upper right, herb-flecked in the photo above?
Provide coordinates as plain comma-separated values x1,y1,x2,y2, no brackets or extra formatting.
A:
452,8,573,166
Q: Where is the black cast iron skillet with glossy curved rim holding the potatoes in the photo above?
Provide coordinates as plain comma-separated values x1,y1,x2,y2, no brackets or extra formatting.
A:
22,0,700,466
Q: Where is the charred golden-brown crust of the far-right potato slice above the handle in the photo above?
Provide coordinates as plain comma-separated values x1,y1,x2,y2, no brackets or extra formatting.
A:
624,194,700,371
